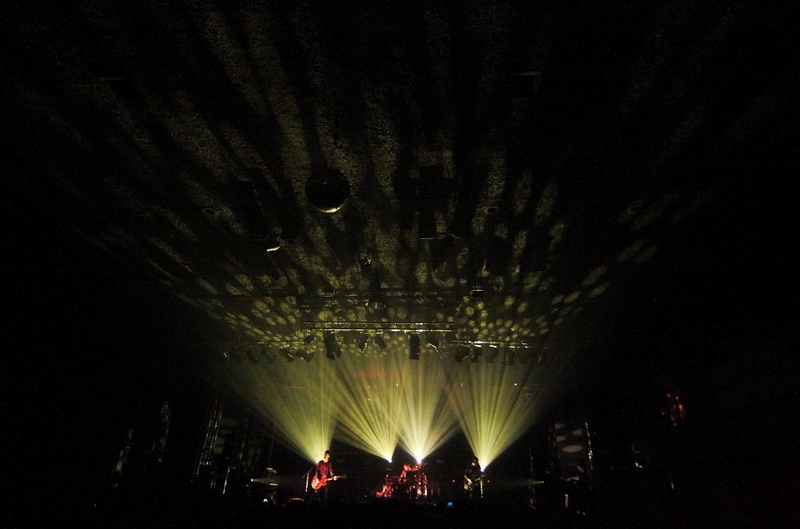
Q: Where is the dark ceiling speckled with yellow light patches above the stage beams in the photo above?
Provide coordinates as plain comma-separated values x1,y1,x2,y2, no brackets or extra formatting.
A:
6,0,800,420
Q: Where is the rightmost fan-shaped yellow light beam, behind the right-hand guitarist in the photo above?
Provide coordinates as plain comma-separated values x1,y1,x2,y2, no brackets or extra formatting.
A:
448,363,538,469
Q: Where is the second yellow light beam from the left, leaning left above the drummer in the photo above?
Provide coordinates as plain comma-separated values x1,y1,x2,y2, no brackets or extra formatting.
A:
336,354,403,463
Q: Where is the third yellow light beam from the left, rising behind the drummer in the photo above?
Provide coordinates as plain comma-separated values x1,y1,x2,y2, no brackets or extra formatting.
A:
392,340,458,463
